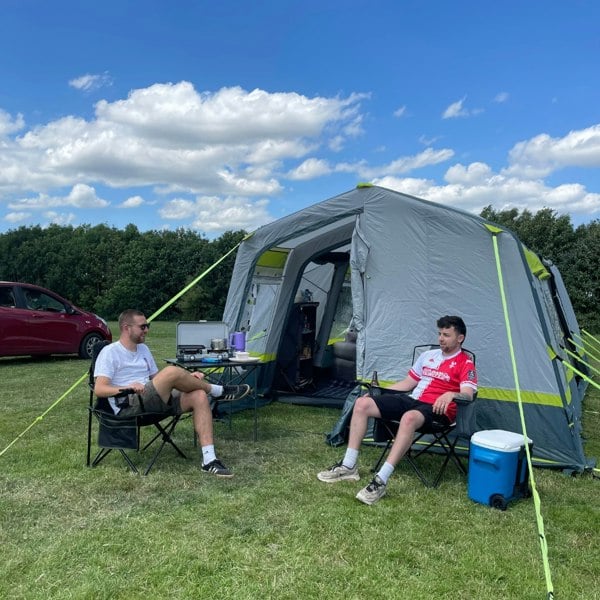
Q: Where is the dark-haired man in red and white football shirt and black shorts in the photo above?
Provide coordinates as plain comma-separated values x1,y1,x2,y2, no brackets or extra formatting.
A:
317,316,477,504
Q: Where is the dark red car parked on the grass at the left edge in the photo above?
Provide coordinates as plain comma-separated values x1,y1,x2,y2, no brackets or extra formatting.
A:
0,281,112,358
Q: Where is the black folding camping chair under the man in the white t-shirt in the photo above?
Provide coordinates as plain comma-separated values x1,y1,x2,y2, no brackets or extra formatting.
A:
86,340,187,475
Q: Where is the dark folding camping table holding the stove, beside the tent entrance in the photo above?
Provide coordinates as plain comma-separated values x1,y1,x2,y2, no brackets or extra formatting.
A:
165,358,265,442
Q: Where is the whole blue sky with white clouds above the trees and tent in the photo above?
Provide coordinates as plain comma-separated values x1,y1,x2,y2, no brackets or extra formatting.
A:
0,0,600,239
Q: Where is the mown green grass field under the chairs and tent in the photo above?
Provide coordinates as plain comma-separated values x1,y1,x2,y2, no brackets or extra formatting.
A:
0,323,600,600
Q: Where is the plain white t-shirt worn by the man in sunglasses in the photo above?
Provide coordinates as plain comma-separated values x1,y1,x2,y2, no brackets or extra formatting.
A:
94,341,158,414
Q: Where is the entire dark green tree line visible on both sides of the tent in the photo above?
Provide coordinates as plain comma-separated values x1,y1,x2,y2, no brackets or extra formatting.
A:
0,206,600,332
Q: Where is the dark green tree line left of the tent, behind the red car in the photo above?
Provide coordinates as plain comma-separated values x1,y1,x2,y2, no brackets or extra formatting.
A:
0,224,245,321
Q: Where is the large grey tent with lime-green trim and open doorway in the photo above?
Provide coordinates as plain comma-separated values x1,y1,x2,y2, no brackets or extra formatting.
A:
224,185,592,471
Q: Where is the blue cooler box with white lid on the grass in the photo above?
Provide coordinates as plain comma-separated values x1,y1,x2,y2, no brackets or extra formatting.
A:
468,429,532,510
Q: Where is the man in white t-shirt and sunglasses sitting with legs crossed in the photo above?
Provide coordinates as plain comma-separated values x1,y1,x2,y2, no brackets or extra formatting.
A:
94,309,250,477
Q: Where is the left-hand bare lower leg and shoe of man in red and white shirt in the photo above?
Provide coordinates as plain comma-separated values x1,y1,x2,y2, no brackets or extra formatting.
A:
317,396,381,483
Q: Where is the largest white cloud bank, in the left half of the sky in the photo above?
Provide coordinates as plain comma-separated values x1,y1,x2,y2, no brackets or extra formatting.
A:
0,81,366,197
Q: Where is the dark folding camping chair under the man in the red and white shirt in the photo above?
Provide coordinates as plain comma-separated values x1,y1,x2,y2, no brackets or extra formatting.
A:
373,344,475,488
